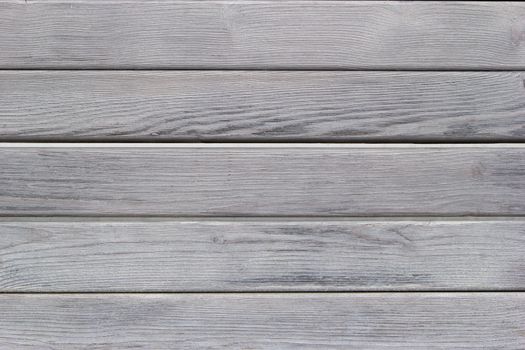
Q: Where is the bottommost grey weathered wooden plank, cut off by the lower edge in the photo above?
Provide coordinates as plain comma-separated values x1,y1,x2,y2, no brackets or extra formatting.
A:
0,293,525,350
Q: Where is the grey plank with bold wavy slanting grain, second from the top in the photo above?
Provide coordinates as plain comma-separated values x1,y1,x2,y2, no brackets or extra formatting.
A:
0,71,525,141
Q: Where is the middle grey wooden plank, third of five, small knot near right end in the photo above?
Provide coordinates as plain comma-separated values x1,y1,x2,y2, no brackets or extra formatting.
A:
0,144,525,216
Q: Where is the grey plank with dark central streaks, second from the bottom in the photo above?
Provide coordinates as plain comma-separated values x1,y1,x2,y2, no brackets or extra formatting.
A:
0,219,525,292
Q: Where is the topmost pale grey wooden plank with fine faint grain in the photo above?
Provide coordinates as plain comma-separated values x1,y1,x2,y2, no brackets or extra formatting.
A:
0,0,525,69
